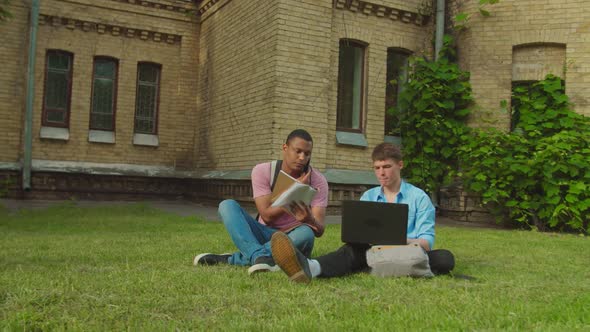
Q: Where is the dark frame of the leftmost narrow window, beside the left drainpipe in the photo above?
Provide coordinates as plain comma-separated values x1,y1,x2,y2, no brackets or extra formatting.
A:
41,49,74,128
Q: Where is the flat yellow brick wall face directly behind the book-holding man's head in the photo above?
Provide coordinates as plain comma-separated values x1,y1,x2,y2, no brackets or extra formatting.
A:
273,0,332,169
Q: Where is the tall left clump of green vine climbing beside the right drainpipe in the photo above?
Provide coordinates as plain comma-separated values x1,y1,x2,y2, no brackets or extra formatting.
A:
392,36,472,194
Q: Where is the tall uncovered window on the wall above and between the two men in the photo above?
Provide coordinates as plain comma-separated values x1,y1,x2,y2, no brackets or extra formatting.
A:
336,39,366,132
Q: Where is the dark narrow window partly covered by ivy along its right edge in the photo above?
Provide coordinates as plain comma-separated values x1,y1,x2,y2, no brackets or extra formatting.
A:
385,48,410,136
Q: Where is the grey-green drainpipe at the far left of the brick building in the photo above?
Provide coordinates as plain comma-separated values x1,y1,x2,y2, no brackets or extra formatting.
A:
22,0,40,191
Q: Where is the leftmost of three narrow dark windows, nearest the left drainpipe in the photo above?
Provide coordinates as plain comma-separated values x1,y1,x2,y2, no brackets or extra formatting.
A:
42,50,74,128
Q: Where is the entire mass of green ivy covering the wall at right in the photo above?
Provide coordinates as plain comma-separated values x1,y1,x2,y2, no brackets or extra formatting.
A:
392,31,590,233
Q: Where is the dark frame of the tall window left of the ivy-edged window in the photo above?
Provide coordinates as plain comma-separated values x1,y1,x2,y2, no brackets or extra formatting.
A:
336,38,369,133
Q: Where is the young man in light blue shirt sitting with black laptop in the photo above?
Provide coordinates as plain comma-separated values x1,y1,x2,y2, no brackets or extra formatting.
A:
271,143,455,282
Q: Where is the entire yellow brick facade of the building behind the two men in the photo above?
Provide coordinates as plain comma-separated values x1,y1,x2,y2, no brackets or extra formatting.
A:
5,0,590,182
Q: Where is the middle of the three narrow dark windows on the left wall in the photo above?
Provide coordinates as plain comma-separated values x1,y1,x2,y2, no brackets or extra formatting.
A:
90,57,118,131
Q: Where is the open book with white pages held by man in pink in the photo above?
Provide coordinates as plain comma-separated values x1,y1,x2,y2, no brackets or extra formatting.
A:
270,170,318,208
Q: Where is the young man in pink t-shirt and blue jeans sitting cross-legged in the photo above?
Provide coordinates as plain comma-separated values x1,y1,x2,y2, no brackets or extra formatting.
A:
194,129,328,274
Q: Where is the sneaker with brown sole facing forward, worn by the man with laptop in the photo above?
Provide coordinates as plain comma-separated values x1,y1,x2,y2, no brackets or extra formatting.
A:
270,232,311,283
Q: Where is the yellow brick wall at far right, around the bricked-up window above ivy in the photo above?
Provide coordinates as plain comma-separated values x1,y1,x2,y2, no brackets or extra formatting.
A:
458,0,590,129
